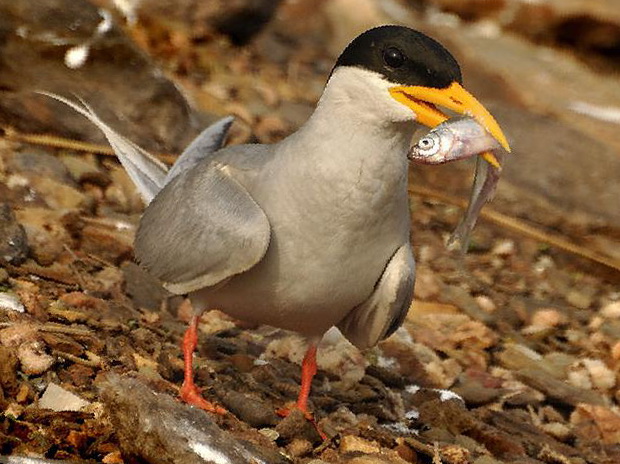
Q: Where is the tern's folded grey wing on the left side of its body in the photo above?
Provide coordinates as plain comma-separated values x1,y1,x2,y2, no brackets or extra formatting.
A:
135,152,271,294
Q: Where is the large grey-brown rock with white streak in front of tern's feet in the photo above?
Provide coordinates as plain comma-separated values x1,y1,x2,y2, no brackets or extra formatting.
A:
100,373,290,464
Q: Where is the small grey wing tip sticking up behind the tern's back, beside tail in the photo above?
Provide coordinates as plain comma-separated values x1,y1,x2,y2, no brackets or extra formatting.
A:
164,116,235,184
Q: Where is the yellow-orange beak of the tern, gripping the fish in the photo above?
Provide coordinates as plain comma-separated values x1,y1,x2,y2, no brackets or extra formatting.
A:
390,82,510,168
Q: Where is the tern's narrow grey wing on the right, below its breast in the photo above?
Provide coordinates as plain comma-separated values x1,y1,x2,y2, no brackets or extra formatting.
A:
338,243,415,349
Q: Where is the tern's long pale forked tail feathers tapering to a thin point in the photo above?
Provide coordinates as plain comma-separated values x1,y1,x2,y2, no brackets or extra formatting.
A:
38,92,168,204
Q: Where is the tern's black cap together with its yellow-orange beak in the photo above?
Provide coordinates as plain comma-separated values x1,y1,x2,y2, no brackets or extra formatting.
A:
332,26,510,166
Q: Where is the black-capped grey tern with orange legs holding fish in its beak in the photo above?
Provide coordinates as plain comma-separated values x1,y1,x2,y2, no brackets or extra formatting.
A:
42,25,510,428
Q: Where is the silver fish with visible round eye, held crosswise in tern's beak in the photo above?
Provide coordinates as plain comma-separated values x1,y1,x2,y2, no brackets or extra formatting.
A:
407,117,500,167
